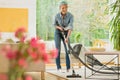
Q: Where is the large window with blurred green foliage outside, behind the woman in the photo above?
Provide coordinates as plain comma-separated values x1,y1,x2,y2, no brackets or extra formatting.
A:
37,0,109,46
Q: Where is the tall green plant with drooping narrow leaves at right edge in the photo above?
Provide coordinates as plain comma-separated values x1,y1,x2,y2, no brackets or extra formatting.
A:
110,0,120,50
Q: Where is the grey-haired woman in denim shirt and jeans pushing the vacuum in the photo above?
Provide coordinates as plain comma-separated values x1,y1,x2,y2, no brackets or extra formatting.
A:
54,1,73,72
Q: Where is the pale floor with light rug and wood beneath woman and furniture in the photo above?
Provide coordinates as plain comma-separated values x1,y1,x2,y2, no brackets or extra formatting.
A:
0,66,120,80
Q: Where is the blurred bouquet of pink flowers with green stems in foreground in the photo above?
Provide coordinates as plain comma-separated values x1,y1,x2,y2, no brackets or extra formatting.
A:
1,28,57,80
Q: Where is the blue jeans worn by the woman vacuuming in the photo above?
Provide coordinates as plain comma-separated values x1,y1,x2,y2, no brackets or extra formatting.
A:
55,32,70,69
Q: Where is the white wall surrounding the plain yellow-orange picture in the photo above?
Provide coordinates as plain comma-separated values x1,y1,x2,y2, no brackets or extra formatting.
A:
0,0,36,40
